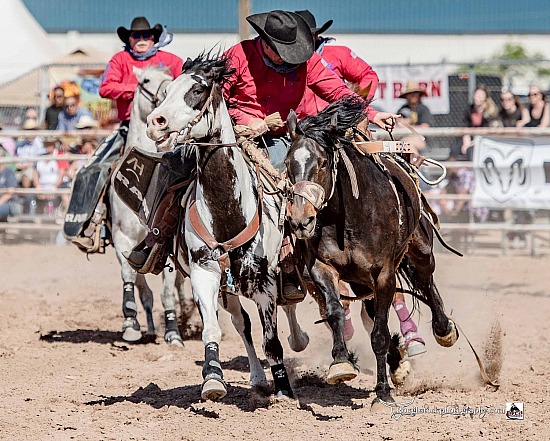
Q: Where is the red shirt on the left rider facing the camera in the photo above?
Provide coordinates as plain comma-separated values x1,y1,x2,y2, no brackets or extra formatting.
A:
99,51,183,121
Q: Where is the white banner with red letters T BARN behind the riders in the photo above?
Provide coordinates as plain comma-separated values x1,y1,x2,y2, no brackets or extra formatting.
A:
373,65,449,115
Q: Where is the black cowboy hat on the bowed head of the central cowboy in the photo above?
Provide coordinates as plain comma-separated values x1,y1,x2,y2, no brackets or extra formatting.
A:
246,11,315,64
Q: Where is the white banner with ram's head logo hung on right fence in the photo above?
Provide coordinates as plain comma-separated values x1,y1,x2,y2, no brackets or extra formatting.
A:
472,136,550,210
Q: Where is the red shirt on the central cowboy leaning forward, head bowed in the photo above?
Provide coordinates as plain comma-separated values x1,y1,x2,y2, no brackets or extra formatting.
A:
223,38,377,133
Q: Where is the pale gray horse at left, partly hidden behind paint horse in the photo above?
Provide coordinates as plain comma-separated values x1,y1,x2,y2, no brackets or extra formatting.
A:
109,67,188,346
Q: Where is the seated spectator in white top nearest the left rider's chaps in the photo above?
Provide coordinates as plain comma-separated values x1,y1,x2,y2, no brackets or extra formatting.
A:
33,137,69,214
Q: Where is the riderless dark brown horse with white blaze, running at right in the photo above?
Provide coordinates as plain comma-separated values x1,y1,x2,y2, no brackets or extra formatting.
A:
286,98,458,402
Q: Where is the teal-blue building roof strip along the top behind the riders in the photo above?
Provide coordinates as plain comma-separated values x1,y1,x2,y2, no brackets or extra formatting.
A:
19,0,550,34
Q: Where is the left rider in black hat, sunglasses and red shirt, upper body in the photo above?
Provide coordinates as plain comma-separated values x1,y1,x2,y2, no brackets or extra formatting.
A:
99,17,183,126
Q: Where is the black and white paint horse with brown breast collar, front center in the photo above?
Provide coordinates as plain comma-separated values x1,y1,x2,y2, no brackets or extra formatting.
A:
147,56,308,399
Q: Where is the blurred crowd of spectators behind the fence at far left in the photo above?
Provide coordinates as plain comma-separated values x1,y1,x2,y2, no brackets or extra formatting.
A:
0,100,99,221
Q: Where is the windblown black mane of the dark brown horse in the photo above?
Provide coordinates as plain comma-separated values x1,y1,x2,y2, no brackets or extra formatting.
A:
296,95,368,150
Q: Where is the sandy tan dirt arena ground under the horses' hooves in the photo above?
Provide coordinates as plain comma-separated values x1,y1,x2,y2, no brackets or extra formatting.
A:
0,244,550,440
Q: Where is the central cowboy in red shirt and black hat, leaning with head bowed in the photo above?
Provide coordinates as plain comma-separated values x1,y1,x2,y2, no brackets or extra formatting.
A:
224,11,396,171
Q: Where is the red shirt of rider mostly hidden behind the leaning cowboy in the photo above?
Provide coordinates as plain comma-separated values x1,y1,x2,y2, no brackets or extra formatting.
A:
302,45,378,115
